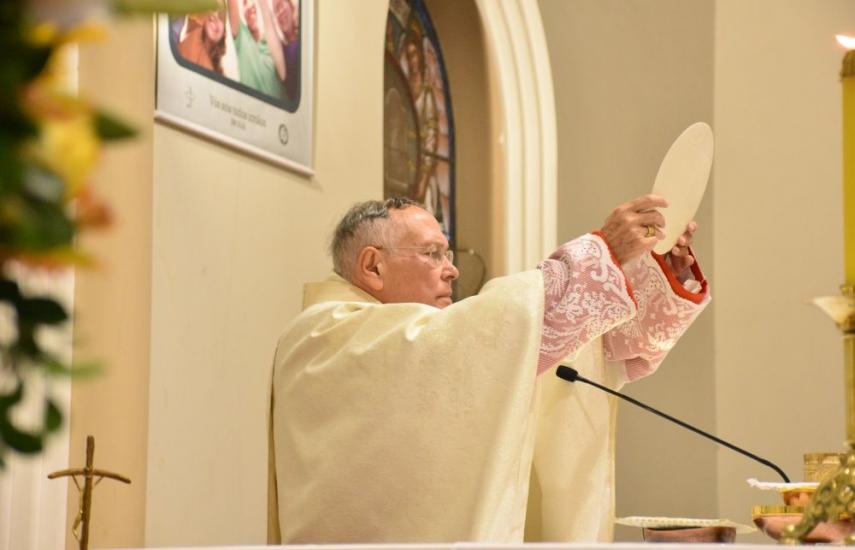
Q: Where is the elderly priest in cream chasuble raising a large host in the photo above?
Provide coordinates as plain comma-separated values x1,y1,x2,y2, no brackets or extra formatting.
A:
271,195,709,543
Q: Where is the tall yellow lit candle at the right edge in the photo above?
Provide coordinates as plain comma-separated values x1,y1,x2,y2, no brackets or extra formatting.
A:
837,35,855,287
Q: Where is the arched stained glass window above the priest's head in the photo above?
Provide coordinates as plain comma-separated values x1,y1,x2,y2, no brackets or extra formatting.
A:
383,0,455,243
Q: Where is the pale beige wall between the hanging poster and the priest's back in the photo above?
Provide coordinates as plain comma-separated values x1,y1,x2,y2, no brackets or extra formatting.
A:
146,0,387,546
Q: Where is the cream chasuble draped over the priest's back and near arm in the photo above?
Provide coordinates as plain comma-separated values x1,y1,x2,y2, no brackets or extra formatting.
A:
272,271,544,543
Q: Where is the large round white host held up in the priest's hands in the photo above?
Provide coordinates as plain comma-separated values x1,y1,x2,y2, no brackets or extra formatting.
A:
652,122,713,254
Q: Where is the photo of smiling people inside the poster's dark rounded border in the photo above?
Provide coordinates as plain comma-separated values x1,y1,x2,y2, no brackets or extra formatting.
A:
169,0,301,113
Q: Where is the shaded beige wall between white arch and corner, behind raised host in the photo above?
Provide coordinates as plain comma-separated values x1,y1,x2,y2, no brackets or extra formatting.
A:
540,0,717,540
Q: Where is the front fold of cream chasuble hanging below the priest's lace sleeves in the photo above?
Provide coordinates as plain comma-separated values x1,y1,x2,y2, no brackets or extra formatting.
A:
526,338,623,542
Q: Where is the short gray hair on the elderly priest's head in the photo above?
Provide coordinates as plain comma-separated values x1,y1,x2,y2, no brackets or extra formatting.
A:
330,197,421,281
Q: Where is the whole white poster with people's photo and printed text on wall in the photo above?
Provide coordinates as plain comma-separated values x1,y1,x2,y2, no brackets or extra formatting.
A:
155,0,314,175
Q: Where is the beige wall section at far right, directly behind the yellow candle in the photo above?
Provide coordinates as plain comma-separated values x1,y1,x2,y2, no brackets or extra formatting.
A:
713,0,855,540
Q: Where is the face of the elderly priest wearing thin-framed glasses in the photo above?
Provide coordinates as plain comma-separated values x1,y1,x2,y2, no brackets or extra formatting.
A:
375,206,460,308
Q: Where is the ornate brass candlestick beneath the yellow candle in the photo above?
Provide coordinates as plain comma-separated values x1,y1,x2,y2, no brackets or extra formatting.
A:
780,286,855,544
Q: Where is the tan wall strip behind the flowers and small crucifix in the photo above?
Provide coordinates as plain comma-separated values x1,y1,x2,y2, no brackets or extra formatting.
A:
67,17,154,548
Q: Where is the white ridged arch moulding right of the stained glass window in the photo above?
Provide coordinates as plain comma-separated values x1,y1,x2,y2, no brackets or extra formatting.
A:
476,0,557,273
